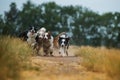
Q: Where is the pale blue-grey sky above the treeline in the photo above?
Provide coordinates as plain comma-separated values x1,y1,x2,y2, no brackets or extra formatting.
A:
0,0,120,14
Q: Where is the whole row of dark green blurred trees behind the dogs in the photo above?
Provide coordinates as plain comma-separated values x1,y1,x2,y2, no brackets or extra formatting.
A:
0,1,120,47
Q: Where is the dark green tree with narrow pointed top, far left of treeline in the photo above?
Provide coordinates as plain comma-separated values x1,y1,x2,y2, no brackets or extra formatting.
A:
3,2,19,35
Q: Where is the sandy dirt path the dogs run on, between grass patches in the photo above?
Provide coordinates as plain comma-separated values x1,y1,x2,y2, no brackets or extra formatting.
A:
22,47,109,80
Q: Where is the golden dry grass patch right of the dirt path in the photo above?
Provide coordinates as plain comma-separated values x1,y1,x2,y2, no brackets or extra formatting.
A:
76,46,120,80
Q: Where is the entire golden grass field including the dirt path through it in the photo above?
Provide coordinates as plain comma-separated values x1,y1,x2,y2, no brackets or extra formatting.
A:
0,36,120,80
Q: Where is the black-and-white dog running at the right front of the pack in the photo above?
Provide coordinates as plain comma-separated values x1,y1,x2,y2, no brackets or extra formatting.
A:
58,33,70,57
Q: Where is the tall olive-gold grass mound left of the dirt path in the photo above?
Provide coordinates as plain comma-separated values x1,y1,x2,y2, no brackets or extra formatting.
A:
0,36,33,80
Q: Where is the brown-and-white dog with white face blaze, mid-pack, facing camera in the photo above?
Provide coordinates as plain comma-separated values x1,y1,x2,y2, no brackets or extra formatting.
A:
43,31,54,56
